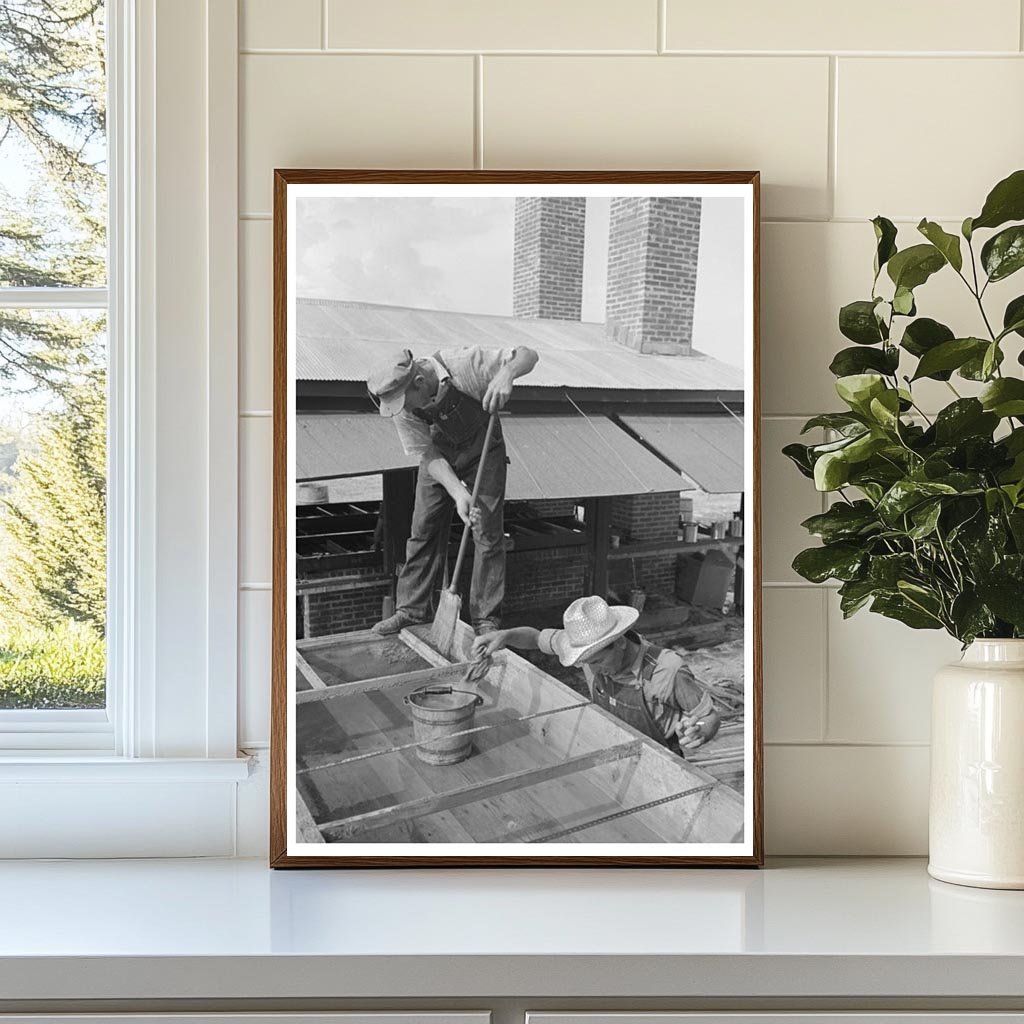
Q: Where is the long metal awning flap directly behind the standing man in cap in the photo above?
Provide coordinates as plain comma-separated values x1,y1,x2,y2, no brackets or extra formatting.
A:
295,413,680,501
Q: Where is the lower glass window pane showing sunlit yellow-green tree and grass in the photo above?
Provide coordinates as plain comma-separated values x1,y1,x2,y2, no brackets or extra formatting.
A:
0,309,106,710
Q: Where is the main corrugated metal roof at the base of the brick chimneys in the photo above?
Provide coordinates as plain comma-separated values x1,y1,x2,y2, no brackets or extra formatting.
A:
295,299,743,392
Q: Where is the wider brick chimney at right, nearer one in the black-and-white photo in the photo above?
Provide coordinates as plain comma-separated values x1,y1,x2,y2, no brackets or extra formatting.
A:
606,196,700,355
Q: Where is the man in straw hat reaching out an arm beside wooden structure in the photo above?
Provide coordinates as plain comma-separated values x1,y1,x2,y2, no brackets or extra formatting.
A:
472,595,721,751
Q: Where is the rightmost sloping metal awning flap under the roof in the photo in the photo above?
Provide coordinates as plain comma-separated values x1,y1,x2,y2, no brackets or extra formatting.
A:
621,413,744,495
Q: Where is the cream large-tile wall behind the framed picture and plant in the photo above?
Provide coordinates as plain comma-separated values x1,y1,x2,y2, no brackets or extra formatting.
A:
239,0,1024,854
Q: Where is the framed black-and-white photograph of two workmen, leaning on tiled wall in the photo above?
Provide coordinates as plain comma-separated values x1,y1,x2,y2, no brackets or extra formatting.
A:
270,170,762,867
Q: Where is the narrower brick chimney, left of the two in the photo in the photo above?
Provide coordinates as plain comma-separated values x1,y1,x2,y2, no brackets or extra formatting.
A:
512,196,587,321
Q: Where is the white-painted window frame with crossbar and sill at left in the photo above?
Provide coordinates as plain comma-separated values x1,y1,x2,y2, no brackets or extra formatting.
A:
0,0,241,770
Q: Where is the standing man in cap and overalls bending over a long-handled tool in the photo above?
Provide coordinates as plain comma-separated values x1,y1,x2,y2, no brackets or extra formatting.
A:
367,346,537,634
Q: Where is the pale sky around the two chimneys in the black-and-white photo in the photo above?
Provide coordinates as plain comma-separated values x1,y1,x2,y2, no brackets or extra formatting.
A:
296,197,743,366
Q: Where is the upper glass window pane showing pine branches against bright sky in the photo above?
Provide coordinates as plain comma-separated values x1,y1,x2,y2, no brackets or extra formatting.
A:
0,0,106,288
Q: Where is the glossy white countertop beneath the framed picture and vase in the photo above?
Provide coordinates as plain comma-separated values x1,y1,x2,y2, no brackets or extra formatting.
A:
0,859,1024,1000
